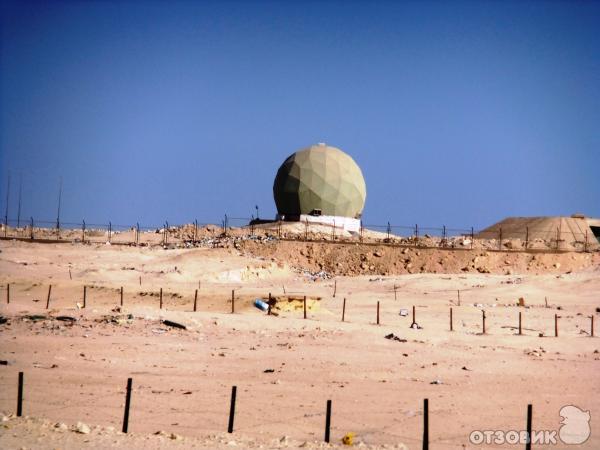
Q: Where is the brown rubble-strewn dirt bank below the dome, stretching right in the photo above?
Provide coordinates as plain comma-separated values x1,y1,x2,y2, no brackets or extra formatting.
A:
240,241,600,276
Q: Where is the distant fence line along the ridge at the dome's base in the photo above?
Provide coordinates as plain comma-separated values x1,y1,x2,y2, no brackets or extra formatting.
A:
0,215,600,252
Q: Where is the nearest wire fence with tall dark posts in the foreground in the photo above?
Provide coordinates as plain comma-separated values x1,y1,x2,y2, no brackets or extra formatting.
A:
0,372,543,449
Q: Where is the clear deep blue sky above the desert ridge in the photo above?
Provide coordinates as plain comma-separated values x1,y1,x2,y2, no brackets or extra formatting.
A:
0,1,600,228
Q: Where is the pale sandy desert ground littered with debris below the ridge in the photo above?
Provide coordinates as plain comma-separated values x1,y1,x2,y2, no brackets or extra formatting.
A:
0,237,600,449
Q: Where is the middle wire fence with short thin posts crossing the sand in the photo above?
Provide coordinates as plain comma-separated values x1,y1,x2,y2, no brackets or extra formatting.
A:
0,280,598,340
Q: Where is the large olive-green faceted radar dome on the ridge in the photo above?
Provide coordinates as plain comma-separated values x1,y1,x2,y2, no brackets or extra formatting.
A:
273,144,367,219
